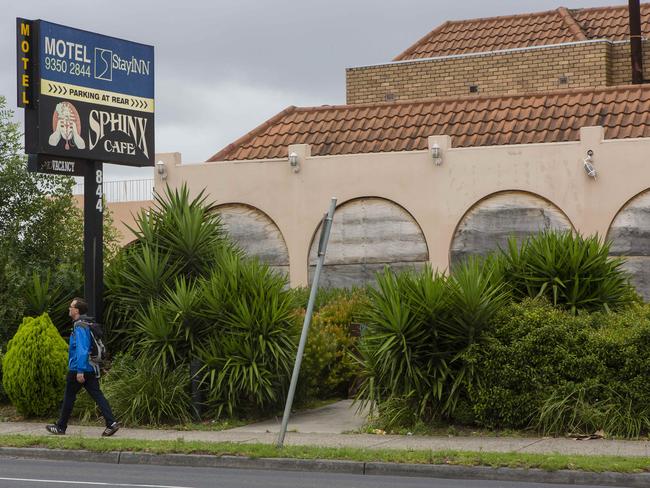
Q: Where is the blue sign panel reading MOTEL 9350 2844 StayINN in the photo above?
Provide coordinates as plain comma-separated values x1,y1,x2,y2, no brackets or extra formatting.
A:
39,20,154,99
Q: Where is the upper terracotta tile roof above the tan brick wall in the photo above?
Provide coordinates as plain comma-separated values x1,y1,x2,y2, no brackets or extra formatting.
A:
394,4,650,61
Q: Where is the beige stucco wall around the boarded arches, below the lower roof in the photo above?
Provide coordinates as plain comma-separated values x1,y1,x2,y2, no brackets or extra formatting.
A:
151,127,650,286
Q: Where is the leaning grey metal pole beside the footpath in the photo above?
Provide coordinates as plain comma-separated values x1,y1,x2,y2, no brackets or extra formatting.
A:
277,197,336,447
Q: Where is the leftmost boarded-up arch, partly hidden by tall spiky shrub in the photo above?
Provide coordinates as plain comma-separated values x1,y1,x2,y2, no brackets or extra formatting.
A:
215,203,289,276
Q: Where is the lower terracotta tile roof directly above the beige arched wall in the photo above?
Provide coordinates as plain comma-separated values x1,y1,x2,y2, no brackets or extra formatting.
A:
208,85,650,161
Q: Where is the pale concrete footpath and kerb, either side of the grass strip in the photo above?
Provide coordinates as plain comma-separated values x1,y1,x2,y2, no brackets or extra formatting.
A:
0,401,650,487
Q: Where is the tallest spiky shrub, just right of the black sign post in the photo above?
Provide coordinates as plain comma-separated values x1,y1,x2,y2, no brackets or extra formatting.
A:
105,185,232,350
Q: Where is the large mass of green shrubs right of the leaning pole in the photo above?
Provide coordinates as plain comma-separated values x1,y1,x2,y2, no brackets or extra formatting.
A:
358,232,650,437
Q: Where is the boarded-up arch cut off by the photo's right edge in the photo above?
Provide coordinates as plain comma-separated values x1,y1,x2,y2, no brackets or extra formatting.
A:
607,189,650,301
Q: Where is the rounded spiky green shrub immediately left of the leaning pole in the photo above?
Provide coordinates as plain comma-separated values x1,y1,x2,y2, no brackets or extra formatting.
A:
198,255,296,416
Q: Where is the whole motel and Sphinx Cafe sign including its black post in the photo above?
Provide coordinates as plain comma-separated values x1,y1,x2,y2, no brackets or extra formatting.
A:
16,18,154,320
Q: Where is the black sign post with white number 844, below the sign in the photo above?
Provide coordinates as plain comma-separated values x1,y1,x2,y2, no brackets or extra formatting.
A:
84,161,104,322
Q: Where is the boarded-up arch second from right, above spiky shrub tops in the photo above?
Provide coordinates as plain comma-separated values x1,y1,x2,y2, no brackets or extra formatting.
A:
449,191,573,267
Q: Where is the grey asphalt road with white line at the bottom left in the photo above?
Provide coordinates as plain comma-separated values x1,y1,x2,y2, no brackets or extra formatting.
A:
0,458,616,488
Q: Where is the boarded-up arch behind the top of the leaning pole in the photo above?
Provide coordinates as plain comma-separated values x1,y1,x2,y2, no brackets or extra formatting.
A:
309,197,429,288
